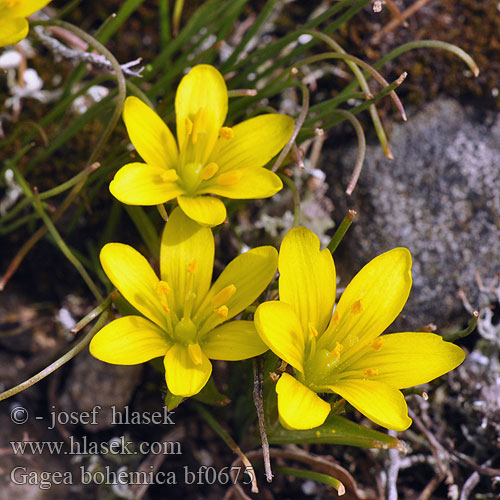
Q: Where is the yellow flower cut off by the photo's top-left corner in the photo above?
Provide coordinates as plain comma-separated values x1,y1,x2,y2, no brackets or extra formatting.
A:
0,0,50,47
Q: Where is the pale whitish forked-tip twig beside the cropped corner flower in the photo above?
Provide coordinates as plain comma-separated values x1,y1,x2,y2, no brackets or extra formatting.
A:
33,26,144,77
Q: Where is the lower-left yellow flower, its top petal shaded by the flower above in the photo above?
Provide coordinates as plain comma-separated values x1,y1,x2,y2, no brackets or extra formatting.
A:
90,208,278,397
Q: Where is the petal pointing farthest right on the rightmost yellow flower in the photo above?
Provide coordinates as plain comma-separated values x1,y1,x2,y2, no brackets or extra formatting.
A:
348,332,465,389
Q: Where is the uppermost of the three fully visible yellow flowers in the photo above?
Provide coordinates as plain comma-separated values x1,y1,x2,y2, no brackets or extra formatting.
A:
109,64,293,226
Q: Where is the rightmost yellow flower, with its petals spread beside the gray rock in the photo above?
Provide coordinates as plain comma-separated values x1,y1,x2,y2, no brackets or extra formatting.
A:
255,227,465,430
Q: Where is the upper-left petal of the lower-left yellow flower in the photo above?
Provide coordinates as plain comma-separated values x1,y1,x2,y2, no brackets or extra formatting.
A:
100,243,168,331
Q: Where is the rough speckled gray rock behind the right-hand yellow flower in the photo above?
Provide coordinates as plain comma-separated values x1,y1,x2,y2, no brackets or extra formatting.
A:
327,99,500,328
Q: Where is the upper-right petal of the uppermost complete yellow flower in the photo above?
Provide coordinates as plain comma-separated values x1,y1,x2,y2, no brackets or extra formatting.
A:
210,114,293,172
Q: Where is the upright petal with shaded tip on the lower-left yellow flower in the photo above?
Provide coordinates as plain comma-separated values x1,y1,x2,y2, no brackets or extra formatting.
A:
160,208,214,314
